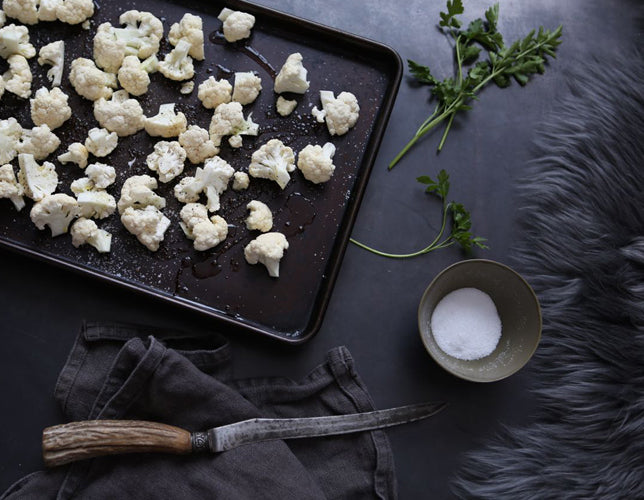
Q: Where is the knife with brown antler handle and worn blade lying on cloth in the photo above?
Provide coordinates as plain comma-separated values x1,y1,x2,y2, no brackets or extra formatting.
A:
42,402,447,467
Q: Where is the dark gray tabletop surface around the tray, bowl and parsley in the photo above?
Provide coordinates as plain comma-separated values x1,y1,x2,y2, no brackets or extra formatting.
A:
0,0,642,499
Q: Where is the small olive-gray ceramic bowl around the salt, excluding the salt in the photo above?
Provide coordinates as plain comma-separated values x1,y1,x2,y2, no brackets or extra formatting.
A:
418,259,541,382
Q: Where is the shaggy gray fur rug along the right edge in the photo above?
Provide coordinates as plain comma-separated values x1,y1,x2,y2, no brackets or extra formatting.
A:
452,57,644,500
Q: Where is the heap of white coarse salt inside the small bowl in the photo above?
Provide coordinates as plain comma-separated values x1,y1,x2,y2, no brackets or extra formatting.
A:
431,288,501,360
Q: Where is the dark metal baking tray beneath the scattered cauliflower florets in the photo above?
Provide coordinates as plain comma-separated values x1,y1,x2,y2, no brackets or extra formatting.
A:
0,0,402,343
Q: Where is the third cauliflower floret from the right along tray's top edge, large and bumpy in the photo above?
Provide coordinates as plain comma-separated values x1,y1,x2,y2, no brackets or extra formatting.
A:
114,10,163,59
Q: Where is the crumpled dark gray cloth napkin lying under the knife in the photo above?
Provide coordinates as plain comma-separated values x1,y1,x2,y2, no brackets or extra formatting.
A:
0,324,396,500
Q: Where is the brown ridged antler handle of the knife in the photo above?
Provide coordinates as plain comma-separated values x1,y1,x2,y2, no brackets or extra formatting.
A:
42,420,198,467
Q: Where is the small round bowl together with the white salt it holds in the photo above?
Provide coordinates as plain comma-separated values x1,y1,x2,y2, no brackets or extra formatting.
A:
418,259,541,382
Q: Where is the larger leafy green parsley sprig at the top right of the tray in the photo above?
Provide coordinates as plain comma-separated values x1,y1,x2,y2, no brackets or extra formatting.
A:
389,0,562,169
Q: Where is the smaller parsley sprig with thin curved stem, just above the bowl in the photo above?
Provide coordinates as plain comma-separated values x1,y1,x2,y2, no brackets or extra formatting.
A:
351,170,487,259
